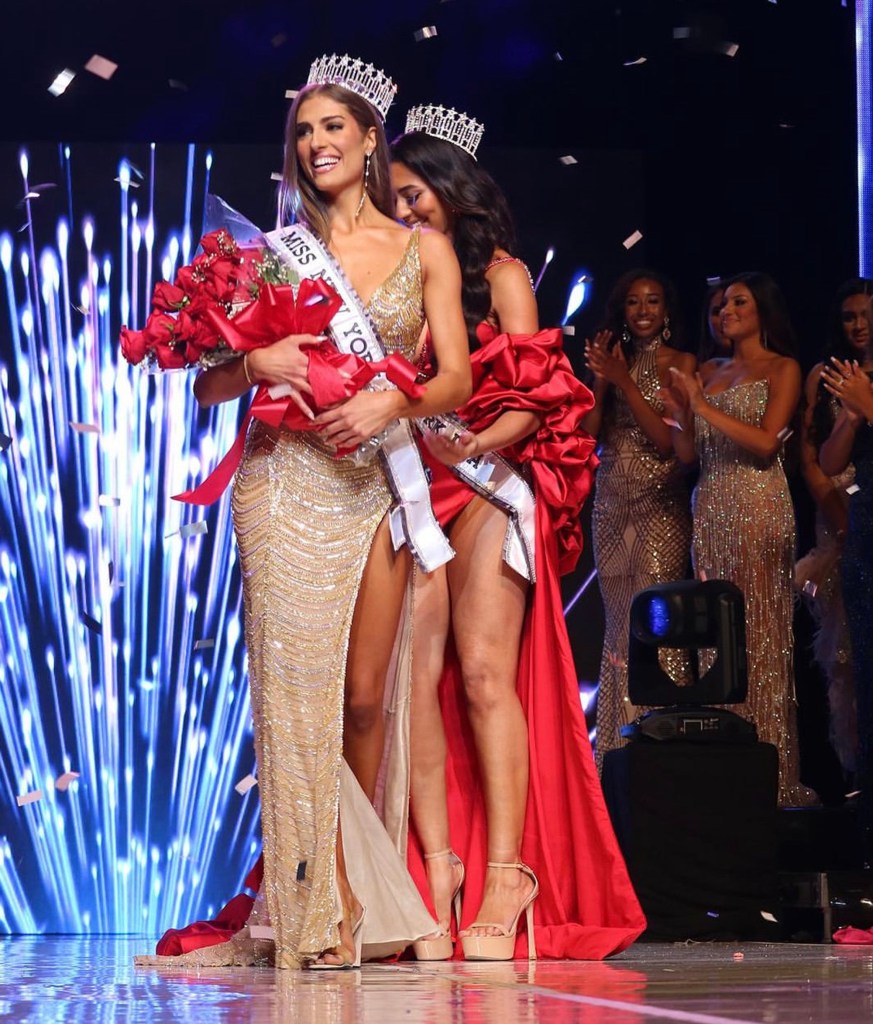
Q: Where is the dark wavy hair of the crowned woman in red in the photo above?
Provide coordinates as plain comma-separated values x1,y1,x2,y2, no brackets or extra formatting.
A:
391,131,516,340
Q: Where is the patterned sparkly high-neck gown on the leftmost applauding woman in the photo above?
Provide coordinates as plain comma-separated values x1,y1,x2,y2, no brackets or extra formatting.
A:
592,338,691,768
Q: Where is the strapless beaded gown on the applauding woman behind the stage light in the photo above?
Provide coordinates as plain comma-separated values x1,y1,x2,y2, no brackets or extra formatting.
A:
692,381,810,804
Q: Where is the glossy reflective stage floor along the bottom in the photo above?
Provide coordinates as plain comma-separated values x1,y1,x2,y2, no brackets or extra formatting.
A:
0,937,873,1024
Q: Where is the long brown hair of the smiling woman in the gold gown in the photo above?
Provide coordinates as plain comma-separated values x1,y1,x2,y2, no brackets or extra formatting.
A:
279,83,394,243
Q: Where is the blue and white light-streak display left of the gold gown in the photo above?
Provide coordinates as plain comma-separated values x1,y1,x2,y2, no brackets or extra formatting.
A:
0,146,259,934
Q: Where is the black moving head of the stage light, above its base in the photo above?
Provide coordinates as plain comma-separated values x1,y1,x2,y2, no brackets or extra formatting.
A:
627,580,748,708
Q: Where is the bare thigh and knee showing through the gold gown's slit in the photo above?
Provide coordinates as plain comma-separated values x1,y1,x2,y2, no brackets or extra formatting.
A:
343,519,411,800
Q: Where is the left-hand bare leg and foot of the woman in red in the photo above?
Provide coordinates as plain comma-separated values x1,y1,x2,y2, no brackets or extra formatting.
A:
409,567,462,932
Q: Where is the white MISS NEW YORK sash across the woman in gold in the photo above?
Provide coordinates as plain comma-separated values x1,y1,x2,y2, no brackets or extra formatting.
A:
266,224,454,572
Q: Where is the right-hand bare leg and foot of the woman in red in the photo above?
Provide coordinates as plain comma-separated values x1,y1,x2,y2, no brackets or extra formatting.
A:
448,498,532,935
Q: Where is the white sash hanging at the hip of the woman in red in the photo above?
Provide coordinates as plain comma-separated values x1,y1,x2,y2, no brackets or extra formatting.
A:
416,415,536,583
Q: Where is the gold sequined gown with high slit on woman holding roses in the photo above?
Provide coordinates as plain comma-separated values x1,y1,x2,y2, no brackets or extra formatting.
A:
140,231,434,967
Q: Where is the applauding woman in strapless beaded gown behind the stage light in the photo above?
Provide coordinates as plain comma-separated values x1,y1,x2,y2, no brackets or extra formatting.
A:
662,273,815,804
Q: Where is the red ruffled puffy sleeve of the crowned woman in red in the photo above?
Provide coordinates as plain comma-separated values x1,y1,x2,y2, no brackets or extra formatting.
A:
457,325,598,575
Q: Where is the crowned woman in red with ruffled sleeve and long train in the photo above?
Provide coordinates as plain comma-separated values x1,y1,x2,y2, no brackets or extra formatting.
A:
392,106,645,959
